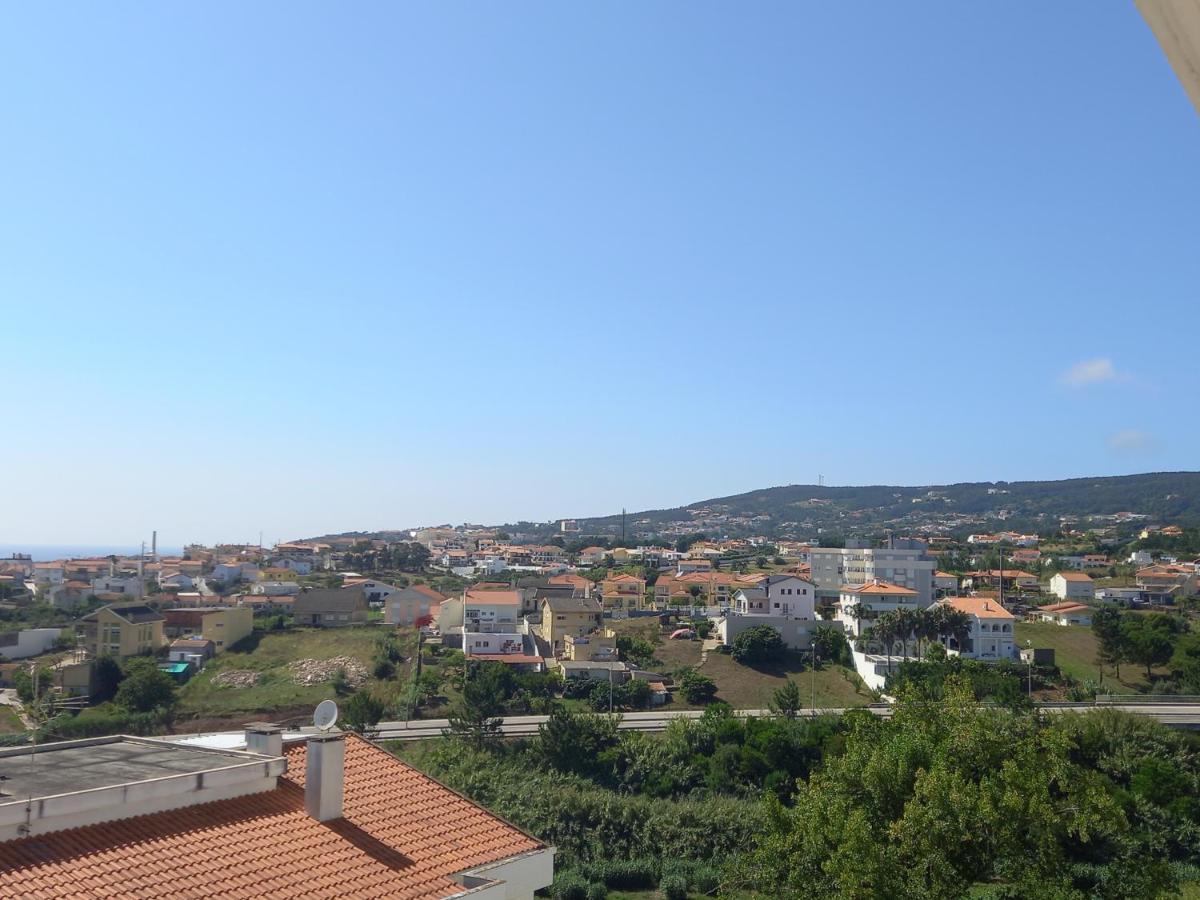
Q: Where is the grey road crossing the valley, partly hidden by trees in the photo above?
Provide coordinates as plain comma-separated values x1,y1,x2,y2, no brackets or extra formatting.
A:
362,703,1200,740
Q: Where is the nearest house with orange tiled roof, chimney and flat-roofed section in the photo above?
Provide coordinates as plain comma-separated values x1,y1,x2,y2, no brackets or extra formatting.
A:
0,726,554,900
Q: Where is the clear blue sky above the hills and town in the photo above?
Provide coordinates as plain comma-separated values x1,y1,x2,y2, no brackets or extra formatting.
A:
0,0,1200,546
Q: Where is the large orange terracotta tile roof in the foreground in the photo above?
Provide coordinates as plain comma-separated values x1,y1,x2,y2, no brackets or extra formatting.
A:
0,734,545,900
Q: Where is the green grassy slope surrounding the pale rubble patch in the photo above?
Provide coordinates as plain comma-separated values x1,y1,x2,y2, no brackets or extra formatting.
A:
176,626,416,730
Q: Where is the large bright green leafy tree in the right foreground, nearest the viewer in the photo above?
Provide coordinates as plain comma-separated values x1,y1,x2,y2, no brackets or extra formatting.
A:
724,683,1175,900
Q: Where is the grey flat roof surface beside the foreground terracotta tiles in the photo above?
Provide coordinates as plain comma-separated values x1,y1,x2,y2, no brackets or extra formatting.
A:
0,737,263,803
